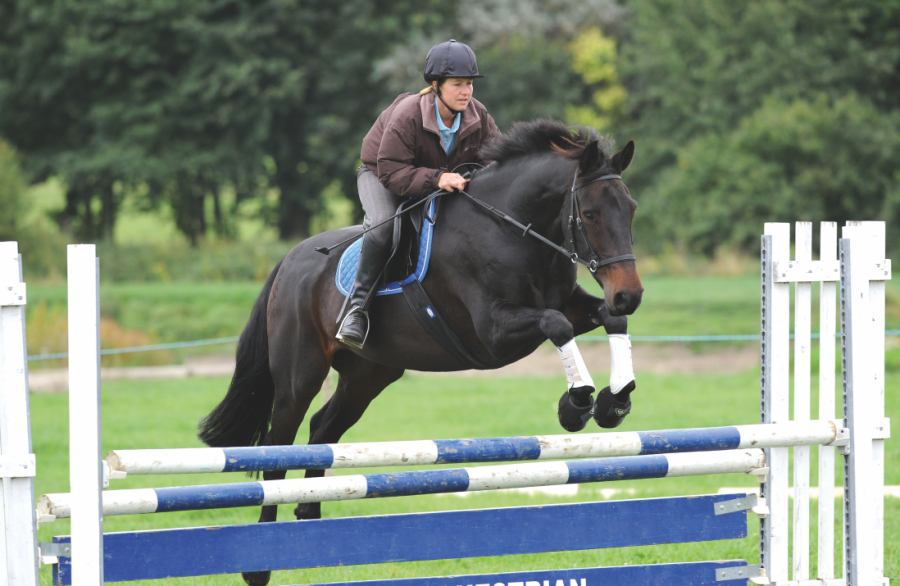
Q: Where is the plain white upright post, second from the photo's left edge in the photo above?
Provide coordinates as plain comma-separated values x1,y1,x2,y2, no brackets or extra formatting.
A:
68,244,103,586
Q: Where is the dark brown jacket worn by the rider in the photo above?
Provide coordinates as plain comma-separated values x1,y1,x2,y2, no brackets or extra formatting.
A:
360,92,500,197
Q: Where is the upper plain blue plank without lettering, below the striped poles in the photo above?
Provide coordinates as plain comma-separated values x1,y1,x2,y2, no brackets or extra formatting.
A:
52,494,747,586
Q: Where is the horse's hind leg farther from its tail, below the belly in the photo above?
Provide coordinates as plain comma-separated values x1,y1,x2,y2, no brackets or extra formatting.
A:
294,351,403,519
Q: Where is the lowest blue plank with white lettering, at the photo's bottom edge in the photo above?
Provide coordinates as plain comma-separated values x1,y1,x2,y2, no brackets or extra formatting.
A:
311,560,747,586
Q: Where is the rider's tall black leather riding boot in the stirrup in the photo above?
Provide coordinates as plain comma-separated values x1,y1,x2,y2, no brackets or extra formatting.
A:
335,236,391,348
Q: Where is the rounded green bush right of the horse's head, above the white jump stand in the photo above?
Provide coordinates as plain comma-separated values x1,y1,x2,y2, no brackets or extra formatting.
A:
646,94,900,255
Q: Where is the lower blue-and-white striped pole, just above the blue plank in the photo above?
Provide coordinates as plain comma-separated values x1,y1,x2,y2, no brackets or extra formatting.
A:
38,449,766,518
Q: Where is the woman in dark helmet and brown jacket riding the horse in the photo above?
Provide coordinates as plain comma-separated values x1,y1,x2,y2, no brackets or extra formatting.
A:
335,39,500,348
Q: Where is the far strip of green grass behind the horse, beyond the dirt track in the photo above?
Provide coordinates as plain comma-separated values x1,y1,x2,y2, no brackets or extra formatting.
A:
28,276,900,350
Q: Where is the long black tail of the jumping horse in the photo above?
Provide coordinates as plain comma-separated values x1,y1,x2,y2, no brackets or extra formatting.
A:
197,262,281,447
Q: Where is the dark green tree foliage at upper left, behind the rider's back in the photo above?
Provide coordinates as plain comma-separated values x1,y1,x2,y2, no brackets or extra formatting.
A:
0,0,448,244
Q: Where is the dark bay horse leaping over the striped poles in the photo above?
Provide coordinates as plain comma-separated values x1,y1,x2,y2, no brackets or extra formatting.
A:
198,120,643,586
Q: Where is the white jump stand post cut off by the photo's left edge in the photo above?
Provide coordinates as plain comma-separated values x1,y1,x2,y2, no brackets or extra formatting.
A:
0,242,38,586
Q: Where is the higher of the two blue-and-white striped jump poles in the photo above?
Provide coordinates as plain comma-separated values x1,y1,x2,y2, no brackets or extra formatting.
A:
107,421,841,477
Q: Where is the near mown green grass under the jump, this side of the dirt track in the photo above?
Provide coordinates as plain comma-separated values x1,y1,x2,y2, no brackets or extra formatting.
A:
31,372,900,585
